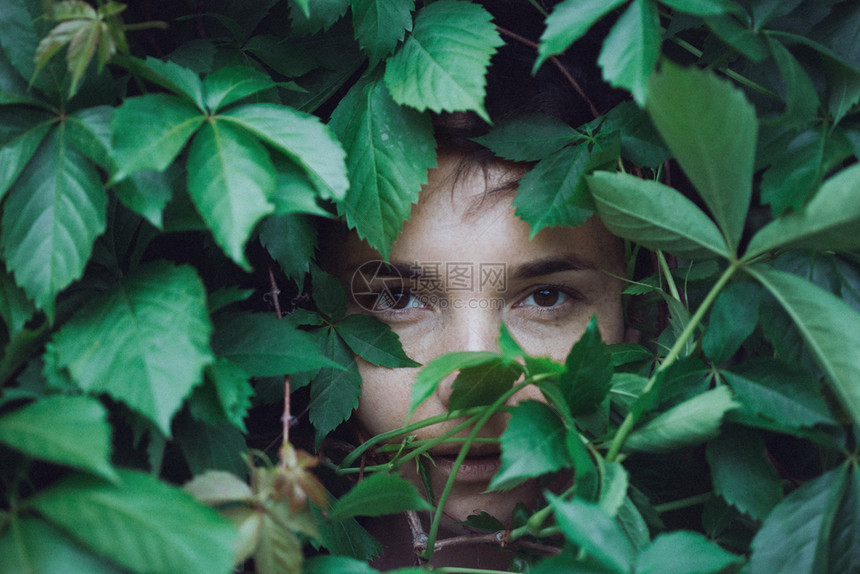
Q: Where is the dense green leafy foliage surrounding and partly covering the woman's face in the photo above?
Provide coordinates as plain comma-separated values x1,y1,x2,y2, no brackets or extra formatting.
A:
0,0,860,574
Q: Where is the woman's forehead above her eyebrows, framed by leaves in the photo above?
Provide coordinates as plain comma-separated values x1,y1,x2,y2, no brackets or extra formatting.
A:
337,156,624,280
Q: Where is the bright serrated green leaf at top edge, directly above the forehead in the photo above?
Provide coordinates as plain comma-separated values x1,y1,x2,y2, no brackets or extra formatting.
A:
385,0,503,121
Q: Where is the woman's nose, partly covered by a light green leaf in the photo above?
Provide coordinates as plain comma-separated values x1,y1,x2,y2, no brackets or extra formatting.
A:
436,308,501,409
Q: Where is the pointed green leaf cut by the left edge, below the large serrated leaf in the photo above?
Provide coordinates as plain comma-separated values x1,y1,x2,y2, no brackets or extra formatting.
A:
0,396,117,480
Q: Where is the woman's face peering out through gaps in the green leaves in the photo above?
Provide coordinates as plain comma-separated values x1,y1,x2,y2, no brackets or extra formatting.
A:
337,155,625,522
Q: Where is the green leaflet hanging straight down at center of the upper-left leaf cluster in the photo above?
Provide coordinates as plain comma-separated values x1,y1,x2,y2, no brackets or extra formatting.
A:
188,121,275,271
